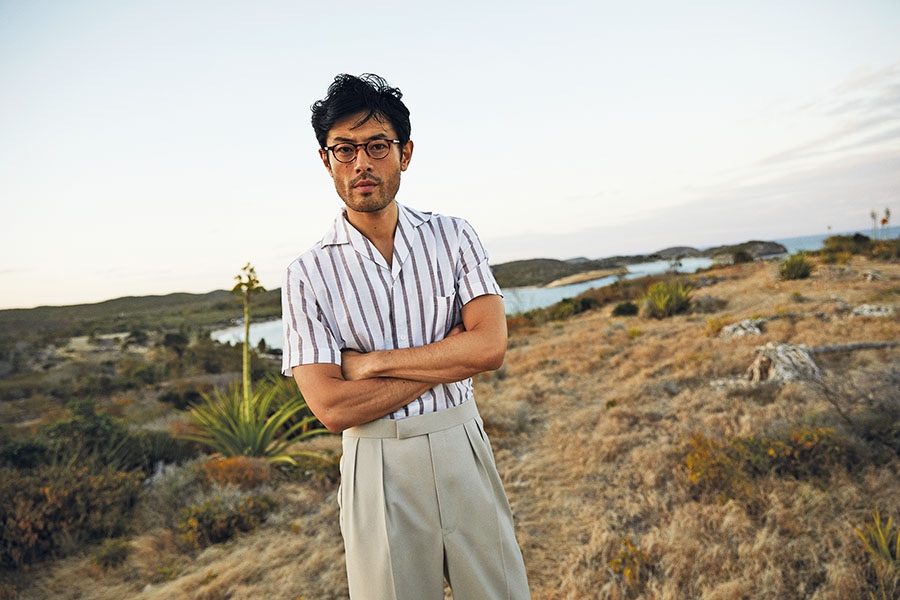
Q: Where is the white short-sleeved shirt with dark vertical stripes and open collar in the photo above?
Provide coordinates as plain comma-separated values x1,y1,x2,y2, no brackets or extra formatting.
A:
281,204,501,419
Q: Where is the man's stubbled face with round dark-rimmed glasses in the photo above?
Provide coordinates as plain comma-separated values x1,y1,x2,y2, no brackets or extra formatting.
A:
319,114,413,213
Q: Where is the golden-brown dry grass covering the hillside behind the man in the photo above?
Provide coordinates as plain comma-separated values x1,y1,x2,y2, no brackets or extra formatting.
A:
10,259,900,600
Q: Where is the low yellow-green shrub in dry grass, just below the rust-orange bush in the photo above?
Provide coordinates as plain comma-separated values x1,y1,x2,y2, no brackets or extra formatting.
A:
178,495,275,550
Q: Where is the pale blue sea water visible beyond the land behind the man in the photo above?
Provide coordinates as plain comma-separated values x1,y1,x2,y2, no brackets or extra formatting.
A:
210,226,900,348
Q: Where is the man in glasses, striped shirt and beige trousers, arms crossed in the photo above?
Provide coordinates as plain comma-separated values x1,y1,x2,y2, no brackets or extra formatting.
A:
282,75,530,600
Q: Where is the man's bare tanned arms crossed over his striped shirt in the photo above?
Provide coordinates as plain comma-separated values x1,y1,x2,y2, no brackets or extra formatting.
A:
292,295,507,432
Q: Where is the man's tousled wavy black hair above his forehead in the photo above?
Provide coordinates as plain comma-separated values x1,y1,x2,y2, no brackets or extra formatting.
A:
311,73,412,148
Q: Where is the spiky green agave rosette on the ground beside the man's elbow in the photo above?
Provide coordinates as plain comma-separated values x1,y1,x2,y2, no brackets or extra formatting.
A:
179,377,328,465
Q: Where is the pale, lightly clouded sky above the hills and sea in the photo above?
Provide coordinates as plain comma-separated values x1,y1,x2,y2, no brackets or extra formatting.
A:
0,0,900,309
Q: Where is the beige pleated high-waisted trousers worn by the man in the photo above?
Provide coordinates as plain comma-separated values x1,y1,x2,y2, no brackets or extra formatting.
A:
338,400,531,600
